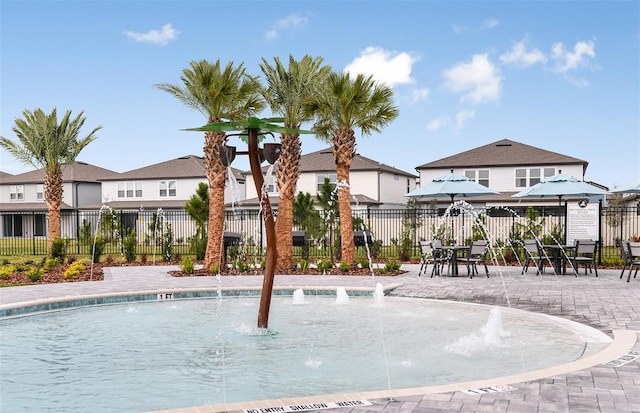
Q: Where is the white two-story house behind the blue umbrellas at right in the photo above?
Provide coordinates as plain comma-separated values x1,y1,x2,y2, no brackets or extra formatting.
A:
416,139,604,207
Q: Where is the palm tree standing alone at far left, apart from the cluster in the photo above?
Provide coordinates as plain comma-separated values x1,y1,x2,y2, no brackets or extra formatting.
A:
0,108,102,246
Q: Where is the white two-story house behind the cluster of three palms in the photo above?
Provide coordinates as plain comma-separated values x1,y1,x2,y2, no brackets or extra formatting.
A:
241,148,417,209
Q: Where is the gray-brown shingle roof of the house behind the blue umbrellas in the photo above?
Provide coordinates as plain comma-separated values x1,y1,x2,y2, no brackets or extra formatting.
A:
416,139,589,170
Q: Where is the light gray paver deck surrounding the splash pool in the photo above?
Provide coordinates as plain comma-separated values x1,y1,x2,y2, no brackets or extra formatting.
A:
0,264,640,413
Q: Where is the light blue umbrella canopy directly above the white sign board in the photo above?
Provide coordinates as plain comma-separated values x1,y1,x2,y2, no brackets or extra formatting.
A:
512,171,607,198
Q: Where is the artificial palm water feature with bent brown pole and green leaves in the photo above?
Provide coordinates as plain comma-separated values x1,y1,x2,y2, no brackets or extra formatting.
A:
187,117,310,328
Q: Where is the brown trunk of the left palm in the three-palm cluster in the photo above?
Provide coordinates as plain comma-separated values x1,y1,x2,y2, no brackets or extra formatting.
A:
204,132,226,271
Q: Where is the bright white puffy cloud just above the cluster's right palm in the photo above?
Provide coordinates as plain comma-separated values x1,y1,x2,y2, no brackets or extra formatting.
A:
344,46,418,87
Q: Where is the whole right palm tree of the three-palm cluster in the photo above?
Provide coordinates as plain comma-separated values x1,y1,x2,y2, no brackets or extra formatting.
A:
303,72,399,265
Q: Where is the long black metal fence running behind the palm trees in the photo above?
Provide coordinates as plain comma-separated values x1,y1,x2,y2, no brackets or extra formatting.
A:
0,206,640,259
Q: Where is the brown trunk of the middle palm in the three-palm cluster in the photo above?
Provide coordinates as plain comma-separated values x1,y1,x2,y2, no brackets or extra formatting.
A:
276,134,301,274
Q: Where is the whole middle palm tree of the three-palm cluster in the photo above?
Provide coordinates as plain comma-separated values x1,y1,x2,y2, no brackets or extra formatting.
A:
260,55,331,273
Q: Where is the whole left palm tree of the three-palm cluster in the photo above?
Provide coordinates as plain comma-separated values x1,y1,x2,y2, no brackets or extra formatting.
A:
154,60,265,271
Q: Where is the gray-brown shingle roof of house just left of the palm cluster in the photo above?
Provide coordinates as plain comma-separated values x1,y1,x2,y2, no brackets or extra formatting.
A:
102,155,244,181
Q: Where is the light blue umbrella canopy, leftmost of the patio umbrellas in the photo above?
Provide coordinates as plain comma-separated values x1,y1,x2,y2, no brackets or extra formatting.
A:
405,170,499,202
